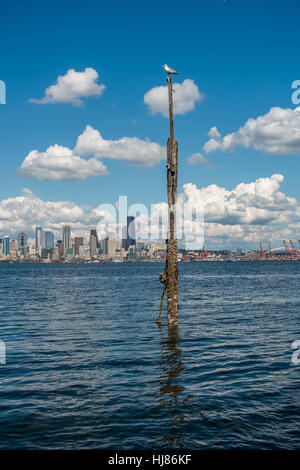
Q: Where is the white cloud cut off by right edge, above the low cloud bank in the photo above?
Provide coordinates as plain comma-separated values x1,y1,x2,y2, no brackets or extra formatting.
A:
204,107,300,155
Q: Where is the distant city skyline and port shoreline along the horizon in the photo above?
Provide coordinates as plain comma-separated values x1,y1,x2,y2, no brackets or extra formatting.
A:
0,220,300,261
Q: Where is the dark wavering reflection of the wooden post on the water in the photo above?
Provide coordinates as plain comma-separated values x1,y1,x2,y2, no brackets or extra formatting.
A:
158,326,192,448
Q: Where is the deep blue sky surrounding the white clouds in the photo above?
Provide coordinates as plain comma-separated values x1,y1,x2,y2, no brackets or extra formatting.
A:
0,0,300,248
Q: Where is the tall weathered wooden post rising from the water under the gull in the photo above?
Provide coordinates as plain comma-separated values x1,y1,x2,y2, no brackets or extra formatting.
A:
157,75,178,326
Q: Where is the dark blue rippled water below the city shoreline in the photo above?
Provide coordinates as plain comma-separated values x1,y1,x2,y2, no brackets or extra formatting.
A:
0,262,300,449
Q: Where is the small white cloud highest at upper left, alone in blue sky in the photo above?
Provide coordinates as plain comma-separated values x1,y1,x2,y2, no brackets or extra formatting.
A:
29,67,106,106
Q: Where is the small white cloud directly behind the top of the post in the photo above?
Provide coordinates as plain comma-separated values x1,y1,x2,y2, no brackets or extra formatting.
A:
144,79,204,117
